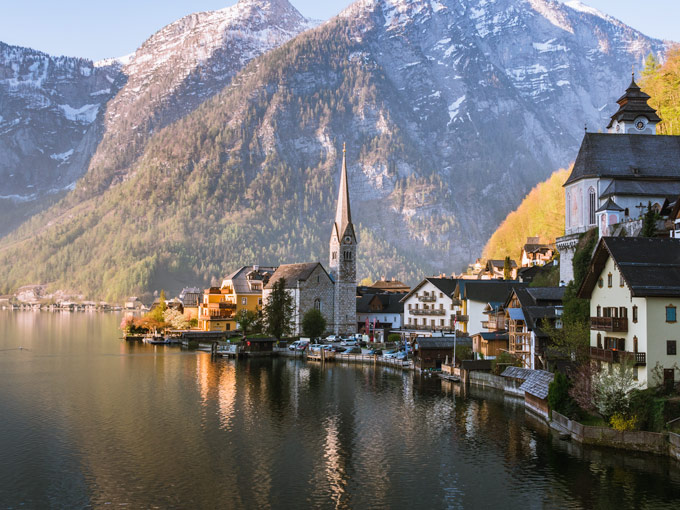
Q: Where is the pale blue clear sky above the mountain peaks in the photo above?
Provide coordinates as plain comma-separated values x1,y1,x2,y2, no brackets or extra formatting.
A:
0,0,680,60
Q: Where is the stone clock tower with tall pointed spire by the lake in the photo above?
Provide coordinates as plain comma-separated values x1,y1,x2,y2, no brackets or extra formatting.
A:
328,144,357,335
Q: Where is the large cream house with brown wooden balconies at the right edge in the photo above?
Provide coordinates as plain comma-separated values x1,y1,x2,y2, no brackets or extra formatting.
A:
578,237,680,387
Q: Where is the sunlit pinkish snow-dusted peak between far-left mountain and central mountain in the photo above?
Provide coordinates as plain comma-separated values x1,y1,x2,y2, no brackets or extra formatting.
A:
78,0,314,196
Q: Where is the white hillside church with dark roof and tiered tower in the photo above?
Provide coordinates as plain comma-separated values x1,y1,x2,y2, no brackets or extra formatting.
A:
557,75,680,283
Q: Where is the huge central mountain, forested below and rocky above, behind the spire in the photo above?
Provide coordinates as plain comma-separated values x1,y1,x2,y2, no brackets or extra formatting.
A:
0,0,663,298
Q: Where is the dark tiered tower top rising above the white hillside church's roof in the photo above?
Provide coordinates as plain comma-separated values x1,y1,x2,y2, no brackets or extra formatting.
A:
607,73,661,135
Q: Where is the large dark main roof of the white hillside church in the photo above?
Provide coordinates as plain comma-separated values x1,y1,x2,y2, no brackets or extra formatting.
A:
564,133,680,186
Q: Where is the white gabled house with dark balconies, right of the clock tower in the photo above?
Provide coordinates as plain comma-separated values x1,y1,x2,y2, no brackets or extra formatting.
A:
401,276,458,331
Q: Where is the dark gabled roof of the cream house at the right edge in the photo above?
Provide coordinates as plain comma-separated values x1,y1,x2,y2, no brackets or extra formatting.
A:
578,237,680,299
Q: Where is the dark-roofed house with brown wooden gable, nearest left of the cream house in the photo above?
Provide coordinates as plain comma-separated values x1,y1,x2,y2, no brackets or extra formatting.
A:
504,287,566,370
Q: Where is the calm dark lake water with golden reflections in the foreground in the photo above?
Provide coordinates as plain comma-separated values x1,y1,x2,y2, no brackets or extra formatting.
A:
0,311,680,510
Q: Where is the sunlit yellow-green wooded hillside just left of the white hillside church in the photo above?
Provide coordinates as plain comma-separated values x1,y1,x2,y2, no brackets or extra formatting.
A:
483,169,571,260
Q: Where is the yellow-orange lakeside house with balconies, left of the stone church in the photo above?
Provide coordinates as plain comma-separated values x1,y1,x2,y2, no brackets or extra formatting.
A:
198,265,276,331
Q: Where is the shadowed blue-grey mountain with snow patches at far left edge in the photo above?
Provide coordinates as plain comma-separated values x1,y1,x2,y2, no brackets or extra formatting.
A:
0,42,123,235
